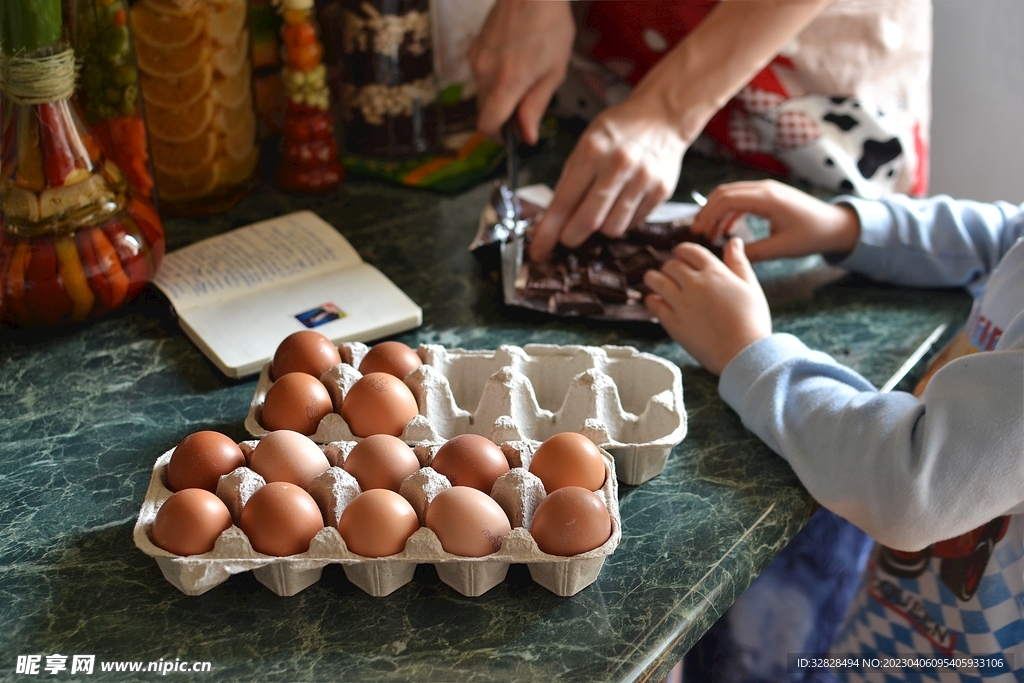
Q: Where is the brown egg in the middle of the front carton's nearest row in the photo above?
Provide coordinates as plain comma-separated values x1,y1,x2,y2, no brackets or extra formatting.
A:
338,488,420,557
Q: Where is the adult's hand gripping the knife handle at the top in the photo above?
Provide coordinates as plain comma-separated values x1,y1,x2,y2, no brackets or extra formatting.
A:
469,0,575,144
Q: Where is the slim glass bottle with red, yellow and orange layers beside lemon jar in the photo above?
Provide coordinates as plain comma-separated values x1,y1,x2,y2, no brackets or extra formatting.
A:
278,0,343,191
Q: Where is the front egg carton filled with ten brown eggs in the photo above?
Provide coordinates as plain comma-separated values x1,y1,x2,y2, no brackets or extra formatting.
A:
134,428,622,596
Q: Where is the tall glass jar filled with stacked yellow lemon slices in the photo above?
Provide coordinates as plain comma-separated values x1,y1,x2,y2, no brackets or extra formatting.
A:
129,0,259,215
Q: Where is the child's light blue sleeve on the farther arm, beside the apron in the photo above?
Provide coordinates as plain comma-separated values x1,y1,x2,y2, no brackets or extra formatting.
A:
829,196,1024,295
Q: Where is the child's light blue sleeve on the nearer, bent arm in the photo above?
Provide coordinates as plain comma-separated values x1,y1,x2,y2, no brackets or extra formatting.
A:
719,334,1024,550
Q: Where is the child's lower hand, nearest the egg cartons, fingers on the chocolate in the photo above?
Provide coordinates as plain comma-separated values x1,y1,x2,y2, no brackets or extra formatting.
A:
644,238,771,375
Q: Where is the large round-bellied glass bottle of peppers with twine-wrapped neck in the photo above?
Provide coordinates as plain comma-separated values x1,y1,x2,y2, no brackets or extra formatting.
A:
0,0,164,326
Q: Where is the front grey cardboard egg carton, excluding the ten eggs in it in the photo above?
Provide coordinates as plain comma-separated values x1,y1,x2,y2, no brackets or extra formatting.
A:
134,430,622,597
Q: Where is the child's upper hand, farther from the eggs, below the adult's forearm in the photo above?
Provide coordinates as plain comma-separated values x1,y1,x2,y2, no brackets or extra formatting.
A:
690,180,860,261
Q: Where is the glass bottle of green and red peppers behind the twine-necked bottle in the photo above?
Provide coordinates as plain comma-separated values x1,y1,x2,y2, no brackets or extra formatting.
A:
69,0,154,199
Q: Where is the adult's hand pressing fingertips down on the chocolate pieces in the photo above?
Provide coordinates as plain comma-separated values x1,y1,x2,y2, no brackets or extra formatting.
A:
529,97,687,261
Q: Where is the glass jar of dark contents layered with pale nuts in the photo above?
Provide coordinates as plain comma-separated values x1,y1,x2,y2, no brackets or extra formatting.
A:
342,0,440,159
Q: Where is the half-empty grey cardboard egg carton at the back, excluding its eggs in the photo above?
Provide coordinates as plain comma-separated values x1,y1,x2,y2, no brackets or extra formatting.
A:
245,342,686,485
